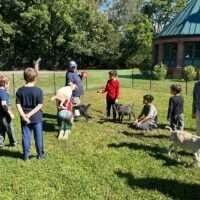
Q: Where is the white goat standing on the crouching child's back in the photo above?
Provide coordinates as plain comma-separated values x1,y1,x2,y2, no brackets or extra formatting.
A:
51,82,77,105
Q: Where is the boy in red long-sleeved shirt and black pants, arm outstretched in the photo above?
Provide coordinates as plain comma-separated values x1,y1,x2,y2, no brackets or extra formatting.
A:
97,70,120,120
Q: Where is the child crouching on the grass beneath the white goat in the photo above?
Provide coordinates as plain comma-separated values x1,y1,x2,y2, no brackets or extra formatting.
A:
57,101,74,140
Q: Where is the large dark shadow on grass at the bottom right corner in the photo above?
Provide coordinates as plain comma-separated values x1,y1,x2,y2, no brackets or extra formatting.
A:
114,170,200,200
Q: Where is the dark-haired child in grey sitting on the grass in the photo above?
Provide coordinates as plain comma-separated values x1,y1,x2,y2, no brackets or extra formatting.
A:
133,95,157,130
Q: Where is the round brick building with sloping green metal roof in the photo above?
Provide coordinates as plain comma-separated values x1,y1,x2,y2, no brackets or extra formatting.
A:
153,0,200,76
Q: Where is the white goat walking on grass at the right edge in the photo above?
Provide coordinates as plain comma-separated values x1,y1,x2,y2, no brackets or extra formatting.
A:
165,126,200,167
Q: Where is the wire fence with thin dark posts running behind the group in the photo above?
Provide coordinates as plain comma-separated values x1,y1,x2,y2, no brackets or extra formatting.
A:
1,70,194,97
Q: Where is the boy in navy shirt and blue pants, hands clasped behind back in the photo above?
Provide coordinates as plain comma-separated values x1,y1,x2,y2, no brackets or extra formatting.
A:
16,68,46,161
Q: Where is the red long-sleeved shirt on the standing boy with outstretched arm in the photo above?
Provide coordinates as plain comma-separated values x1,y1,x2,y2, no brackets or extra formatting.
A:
102,80,120,99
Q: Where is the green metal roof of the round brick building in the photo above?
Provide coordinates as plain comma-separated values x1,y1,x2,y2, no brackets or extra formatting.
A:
156,0,200,38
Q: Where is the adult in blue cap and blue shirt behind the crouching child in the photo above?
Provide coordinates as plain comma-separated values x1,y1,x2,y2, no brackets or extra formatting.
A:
65,60,84,105
